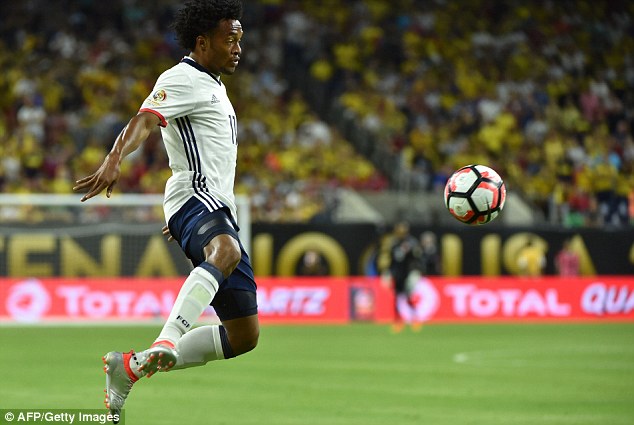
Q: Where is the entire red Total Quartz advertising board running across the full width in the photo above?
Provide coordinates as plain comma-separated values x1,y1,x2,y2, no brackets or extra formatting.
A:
0,276,634,323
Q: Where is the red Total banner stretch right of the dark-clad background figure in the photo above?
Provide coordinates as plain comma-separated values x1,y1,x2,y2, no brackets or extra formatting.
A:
390,276,634,322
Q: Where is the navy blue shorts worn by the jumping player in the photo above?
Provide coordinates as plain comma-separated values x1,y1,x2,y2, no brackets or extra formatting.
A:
168,197,258,321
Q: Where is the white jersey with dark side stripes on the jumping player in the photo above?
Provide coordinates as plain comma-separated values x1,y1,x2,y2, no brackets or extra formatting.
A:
140,57,238,222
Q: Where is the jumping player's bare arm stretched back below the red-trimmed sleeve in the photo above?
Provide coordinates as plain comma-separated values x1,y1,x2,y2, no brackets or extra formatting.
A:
73,112,160,202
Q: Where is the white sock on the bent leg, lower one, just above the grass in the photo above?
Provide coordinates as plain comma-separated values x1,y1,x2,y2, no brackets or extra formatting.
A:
172,325,225,369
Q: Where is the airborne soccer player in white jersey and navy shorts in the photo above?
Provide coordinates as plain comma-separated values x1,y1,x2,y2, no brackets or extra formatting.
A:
73,0,259,415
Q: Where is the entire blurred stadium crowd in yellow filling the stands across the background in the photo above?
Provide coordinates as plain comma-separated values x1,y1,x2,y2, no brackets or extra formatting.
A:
0,0,634,226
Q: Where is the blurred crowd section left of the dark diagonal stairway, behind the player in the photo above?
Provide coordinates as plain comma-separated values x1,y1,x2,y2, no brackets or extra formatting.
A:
0,0,387,221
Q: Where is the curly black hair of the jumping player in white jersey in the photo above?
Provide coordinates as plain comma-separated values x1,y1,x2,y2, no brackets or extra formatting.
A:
172,0,242,50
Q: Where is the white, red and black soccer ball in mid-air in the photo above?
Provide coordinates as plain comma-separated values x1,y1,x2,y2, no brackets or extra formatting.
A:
445,165,506,225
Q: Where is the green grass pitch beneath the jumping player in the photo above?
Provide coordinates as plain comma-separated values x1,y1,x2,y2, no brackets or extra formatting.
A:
0,323,634,425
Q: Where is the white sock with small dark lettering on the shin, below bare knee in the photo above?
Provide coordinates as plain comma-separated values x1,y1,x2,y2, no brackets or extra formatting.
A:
156,267,218,345
